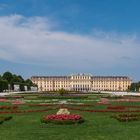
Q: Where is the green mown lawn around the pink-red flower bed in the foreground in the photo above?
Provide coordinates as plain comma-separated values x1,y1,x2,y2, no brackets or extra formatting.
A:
0,95,140,140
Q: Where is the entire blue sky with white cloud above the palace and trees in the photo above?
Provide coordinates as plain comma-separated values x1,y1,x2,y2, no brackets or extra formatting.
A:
0,0,140,81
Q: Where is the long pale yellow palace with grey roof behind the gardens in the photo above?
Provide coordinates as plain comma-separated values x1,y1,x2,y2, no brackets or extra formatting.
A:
31,74,132,91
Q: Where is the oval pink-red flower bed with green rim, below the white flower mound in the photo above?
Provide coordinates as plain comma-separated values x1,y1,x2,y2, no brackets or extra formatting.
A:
41,114,84,124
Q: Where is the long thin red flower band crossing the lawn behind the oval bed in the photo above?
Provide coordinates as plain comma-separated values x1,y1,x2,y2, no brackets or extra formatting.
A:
0,104,140,114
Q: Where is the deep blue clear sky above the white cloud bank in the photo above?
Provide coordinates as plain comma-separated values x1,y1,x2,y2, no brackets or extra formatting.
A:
0,0,140,33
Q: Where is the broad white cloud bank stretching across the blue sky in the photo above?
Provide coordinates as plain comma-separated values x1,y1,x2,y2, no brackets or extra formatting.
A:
0,15,140,69
